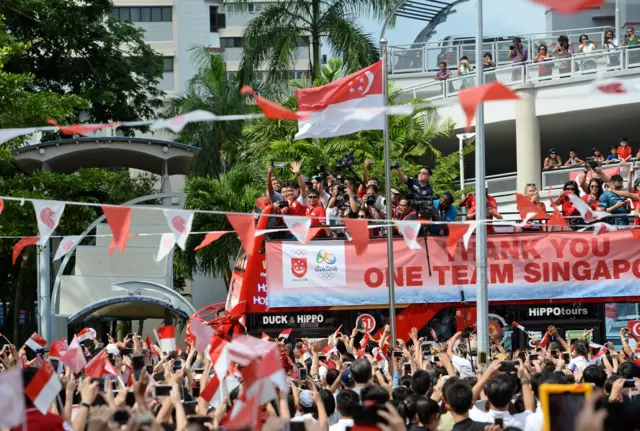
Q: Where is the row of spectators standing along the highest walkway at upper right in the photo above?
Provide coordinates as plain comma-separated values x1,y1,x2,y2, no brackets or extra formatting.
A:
434,27,640,85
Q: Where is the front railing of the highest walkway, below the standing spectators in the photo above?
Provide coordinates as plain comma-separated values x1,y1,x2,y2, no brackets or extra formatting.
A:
401,47,640,100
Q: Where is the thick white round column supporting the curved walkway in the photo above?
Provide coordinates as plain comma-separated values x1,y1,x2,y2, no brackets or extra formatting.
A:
515,90,542,193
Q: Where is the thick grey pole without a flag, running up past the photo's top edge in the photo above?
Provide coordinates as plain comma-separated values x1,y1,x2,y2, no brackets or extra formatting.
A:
475,0,489,364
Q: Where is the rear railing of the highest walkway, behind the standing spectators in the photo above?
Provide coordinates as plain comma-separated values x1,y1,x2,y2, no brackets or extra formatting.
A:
388,27,608,75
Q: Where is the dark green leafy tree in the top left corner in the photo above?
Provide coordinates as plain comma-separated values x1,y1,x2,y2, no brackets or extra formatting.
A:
0,0,162,125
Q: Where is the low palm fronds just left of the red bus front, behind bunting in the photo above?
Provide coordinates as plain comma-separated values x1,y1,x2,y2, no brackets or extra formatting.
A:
174,164,265,285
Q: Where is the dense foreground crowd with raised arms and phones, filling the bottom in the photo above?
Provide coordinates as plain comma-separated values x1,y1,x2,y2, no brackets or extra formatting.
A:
0,326,640,431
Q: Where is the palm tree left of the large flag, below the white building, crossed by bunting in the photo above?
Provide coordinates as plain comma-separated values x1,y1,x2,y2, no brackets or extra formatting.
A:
167,47,253,177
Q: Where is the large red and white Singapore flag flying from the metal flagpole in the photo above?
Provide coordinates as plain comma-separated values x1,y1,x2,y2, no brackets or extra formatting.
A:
295,61,385,139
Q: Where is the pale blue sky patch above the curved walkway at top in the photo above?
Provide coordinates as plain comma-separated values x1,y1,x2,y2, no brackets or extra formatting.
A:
359,0,546,46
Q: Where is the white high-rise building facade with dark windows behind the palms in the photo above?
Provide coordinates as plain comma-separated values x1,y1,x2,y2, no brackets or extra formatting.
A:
112,0,311,96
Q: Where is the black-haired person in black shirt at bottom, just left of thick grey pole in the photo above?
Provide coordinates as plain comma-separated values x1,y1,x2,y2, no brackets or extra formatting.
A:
442,377,502,431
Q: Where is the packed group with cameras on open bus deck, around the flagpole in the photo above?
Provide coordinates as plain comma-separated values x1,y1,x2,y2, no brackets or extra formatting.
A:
265,159,503,237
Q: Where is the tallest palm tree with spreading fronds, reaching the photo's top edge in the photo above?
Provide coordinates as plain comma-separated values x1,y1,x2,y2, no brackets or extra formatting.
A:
240,0,388,82
